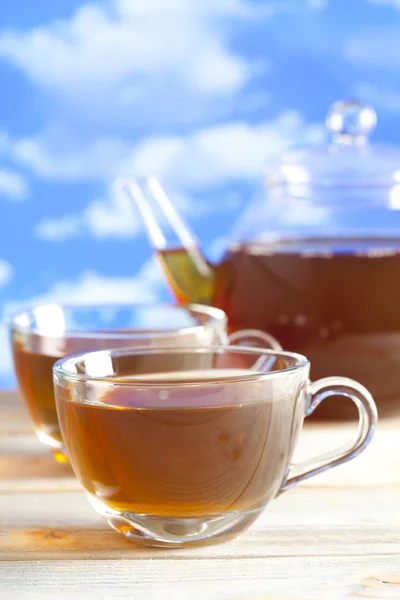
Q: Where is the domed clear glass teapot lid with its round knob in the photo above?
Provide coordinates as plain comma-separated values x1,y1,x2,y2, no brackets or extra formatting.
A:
267,100,400,188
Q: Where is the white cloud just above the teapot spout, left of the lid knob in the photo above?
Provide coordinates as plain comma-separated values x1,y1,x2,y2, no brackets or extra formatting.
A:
121,111,324,189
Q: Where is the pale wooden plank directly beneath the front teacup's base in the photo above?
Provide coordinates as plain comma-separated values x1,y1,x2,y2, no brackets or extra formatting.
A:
0,486,400,564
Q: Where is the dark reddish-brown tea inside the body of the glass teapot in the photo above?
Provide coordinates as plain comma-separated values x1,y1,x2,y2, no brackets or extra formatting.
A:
213,240,400,417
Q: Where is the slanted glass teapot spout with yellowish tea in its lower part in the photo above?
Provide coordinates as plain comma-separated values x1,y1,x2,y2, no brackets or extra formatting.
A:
120,177,214,304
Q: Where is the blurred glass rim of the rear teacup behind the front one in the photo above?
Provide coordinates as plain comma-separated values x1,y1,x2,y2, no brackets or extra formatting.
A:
7,302,228,341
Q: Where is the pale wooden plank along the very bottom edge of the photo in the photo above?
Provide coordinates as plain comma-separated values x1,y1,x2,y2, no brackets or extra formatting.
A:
0,554,399,600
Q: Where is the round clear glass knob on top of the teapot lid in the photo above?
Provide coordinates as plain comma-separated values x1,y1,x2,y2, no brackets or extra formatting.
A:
325,100,377,145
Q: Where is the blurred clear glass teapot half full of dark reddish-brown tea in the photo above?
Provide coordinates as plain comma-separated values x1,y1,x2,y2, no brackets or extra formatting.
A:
123,101,400,417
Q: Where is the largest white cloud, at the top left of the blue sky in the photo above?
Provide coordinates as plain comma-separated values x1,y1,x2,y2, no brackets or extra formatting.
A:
0,0,256,126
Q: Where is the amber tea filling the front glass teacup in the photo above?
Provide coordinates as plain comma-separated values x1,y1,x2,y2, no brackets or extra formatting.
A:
57,369,294,517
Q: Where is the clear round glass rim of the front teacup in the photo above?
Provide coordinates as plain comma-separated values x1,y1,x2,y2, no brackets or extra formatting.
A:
53,345,310,389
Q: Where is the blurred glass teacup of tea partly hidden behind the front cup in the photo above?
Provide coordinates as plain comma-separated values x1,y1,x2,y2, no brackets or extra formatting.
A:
10,304,279,463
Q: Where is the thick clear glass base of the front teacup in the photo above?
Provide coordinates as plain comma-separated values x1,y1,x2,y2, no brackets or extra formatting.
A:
88,494,263,548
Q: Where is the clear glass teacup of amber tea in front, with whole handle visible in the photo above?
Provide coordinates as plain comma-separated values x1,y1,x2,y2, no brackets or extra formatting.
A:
53,346,377,547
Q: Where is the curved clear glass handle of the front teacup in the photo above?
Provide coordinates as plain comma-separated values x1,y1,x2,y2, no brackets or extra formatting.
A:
278,377,378,495
